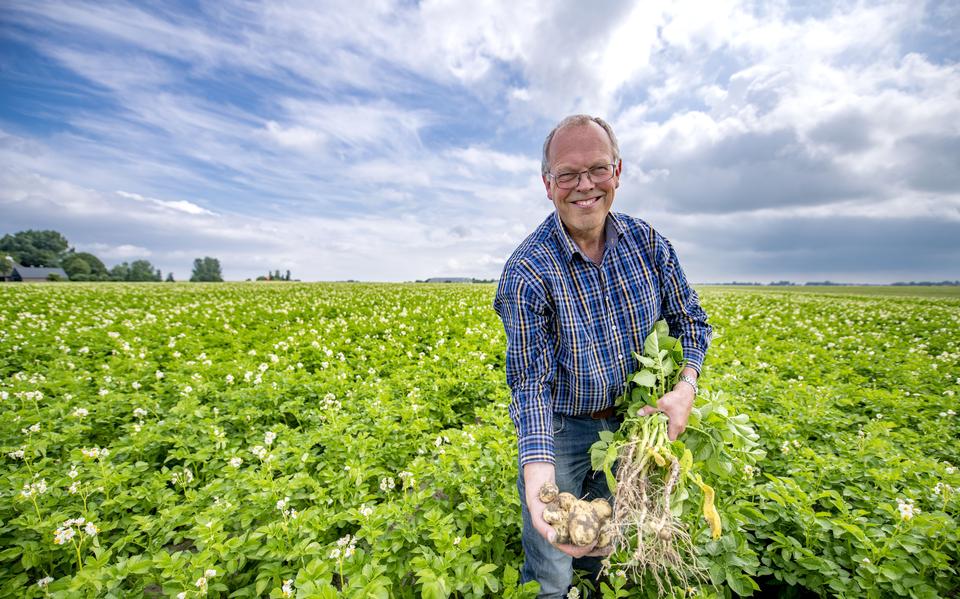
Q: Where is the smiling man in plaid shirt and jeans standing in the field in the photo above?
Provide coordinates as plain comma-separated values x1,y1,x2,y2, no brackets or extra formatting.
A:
494,115,711,597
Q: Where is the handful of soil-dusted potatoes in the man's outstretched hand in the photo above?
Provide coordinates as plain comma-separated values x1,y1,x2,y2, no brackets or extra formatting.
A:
540,483,613,548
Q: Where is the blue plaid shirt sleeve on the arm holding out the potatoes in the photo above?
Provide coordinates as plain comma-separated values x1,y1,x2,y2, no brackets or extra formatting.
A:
494,268,555,468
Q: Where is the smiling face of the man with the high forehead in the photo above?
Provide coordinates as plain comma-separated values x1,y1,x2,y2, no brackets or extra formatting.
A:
543,122,621,241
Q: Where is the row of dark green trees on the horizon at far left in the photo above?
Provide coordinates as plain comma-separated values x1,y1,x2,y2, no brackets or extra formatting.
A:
0,229,223,283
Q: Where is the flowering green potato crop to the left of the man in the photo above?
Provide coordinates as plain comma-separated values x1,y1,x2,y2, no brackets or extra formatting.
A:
0,284,536,598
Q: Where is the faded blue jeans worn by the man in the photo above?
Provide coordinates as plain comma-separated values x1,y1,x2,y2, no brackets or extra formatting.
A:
517,414,620,599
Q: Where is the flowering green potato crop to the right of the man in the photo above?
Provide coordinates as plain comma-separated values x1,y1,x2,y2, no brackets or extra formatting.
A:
705,291,960,597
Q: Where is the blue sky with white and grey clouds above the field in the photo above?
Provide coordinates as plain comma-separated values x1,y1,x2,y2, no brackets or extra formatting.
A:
0,0,960,283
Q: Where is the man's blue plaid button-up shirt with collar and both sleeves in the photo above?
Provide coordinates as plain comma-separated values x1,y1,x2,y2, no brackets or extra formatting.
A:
493,212,711,468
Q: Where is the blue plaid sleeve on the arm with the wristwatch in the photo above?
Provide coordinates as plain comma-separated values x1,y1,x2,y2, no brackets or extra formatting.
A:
655,234,713,373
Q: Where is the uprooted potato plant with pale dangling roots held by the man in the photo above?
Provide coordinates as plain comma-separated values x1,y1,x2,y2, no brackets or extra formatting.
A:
590,320,764,594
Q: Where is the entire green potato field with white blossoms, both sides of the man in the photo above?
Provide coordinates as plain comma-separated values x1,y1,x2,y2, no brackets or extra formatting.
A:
0,283,960,599
